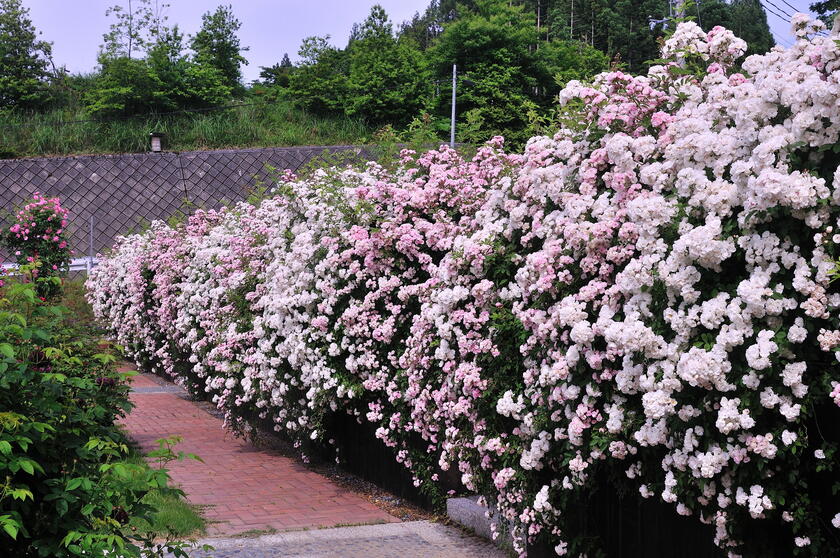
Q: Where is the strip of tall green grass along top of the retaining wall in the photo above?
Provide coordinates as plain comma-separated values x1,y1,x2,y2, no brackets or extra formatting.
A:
0,102,374,158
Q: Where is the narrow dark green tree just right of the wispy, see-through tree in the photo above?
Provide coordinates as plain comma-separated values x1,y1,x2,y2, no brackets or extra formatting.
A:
190,5,248,93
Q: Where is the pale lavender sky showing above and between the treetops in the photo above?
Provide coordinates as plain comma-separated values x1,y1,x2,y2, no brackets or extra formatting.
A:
23,0,811,82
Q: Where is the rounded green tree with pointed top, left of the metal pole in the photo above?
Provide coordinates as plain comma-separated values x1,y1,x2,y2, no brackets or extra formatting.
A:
345,5,430,125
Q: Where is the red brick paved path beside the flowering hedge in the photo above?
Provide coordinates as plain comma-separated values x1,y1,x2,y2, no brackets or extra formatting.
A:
117,368,399,535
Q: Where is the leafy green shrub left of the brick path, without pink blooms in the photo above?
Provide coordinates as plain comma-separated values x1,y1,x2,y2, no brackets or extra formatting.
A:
0,278,199,558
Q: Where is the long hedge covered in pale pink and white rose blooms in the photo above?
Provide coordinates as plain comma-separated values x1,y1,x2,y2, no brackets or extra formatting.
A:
88,15,840,556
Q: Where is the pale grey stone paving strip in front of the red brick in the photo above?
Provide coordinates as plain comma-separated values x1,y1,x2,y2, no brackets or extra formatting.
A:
183,521,508,558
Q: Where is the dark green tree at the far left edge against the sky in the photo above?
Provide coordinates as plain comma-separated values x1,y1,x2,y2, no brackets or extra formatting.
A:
0,0,52,109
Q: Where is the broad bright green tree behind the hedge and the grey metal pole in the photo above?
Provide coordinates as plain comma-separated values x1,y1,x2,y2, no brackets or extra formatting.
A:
430,0,607,146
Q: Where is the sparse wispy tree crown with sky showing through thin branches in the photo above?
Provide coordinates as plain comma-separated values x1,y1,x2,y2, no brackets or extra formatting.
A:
100,0,169,58
